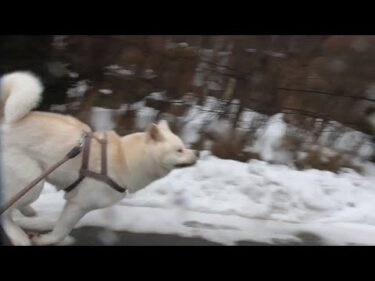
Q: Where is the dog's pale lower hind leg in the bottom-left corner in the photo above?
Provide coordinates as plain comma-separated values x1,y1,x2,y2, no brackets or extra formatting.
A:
2,210,31,246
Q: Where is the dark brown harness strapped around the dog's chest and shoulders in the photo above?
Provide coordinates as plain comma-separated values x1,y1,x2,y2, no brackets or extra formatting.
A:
64,132,126,193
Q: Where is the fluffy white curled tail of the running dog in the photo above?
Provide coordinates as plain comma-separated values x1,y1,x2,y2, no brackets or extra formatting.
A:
0,71,44,123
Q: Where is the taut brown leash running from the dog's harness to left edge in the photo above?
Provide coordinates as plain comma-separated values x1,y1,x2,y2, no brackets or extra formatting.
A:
0,133,87,216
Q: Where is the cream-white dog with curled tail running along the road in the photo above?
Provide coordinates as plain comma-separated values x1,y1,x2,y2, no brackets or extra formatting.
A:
0,72,198,245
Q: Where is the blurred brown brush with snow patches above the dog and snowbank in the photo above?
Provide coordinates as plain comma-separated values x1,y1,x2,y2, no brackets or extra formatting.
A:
0,35,375,171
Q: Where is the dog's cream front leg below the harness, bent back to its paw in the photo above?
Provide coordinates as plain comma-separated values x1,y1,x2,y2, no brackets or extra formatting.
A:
32,201,90,245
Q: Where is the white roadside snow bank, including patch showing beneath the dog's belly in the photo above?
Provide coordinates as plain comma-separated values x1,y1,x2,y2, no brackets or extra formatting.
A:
16,152,375,245
